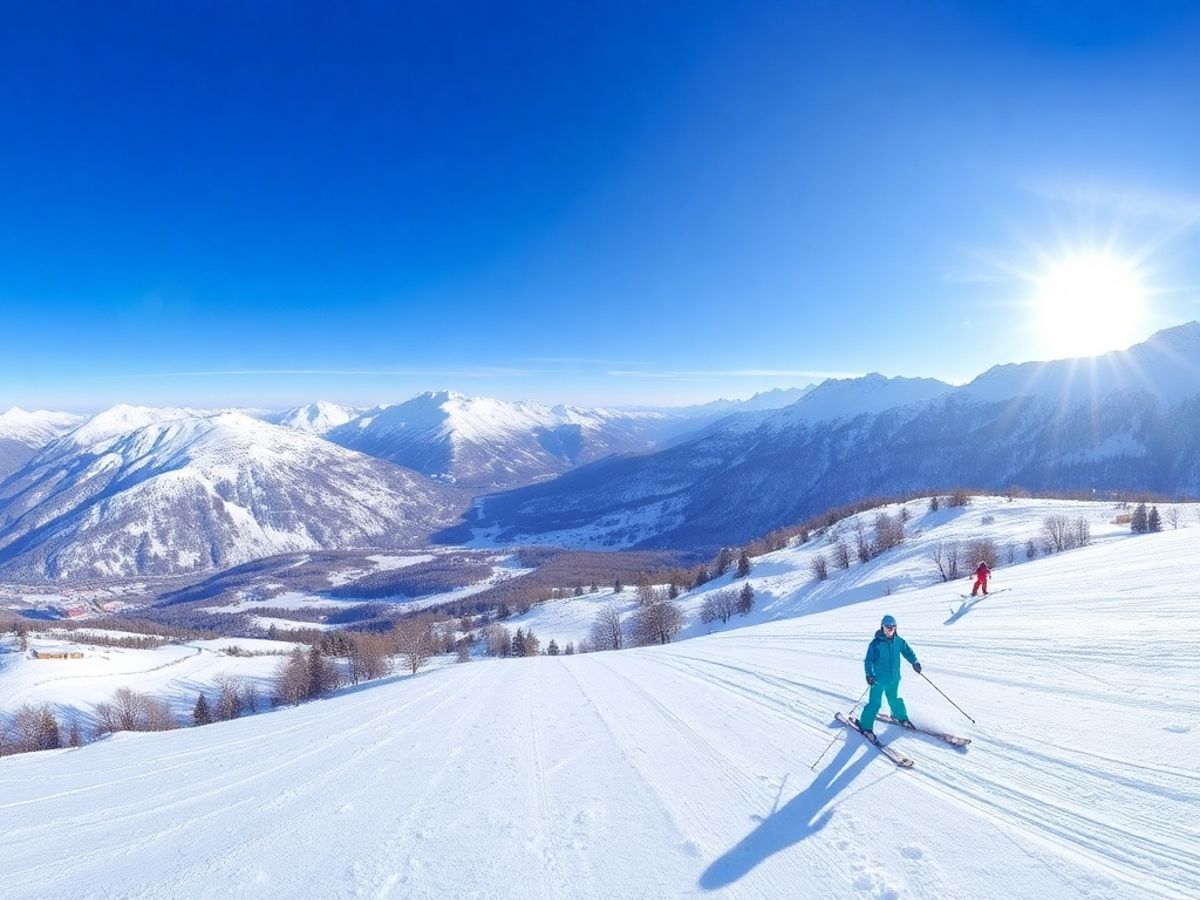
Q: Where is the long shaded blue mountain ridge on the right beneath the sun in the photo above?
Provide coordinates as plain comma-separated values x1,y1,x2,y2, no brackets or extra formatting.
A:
465,323,1200,550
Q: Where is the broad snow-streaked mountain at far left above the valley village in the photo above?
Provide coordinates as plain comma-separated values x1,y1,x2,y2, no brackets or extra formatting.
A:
0,407,466,578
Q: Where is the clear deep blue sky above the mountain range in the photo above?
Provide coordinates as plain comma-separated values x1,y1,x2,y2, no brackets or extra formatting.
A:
0,2,1200,409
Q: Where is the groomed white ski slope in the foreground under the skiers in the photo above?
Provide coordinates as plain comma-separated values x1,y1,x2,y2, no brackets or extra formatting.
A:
0,524,1200,900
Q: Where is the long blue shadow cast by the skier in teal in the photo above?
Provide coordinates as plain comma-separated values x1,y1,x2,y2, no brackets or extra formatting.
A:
700,726,877,890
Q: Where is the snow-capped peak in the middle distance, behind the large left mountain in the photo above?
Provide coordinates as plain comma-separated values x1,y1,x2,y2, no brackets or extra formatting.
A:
326,391,668,487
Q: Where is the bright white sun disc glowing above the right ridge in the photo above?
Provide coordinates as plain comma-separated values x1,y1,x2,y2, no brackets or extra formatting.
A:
1037,253,1145,358
